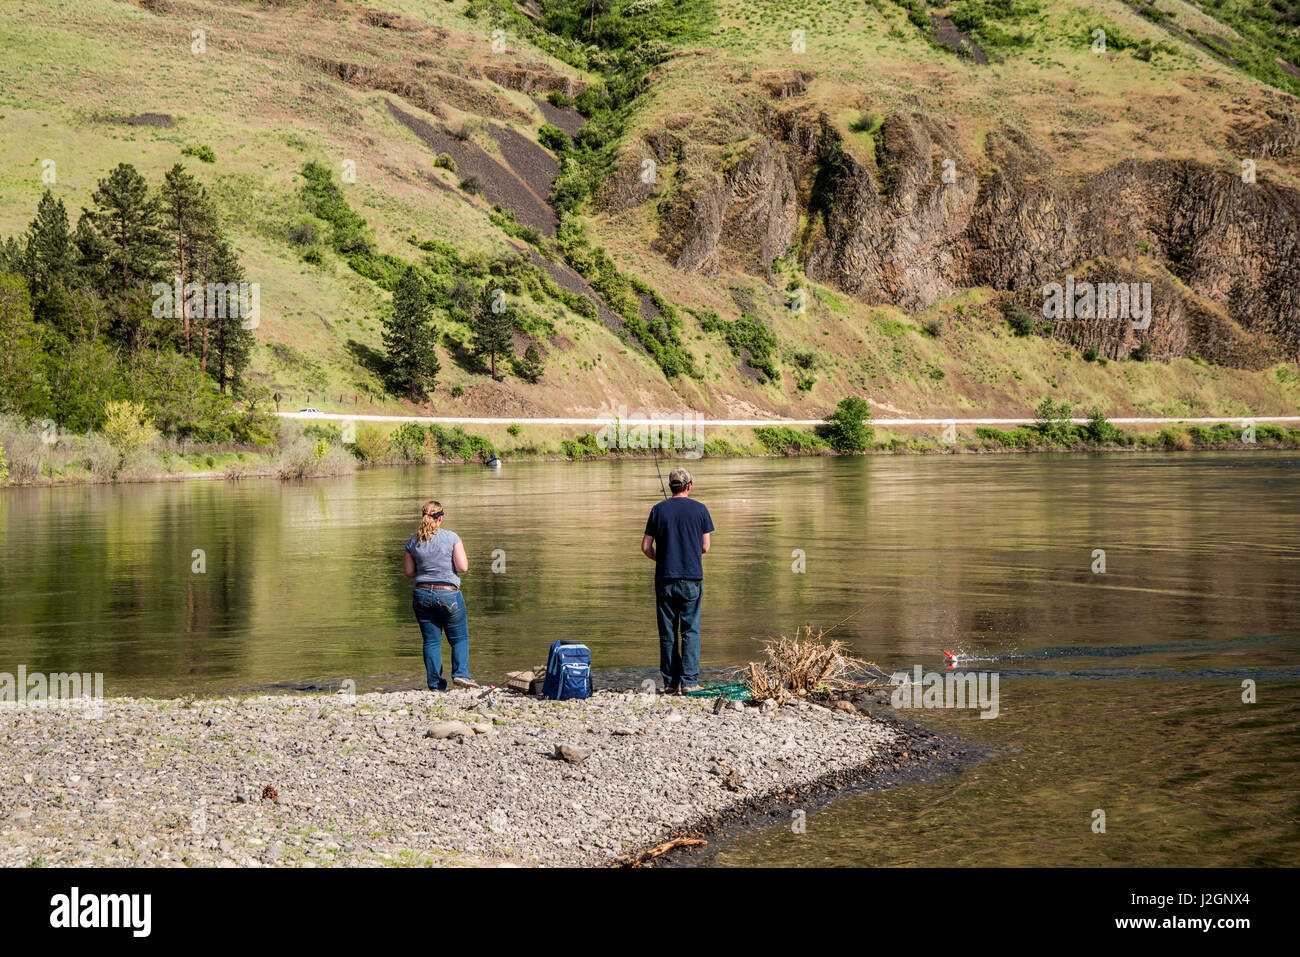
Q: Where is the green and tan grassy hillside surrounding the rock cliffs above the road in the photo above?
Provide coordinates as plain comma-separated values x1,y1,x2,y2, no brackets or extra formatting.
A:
0,0,1300,426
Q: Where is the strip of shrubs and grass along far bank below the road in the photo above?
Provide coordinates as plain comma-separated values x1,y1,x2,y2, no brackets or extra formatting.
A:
0,397,1300,486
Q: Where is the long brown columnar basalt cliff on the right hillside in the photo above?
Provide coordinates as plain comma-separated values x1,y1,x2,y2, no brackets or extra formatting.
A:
618,98,1300,367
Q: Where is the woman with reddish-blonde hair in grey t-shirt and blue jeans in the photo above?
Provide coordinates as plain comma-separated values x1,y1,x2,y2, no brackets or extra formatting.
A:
402,501,478,692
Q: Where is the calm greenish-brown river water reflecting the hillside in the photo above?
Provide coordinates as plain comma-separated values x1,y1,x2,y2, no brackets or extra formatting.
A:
0,452,1300,865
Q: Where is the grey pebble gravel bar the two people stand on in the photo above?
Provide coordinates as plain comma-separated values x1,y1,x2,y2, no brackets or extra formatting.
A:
0,689,963,867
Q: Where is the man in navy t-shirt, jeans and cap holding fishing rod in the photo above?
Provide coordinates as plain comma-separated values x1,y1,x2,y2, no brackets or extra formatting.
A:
641,468,714,694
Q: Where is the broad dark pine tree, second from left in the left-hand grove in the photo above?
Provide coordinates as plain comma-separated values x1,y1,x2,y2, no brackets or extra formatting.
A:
85,163,166,293
